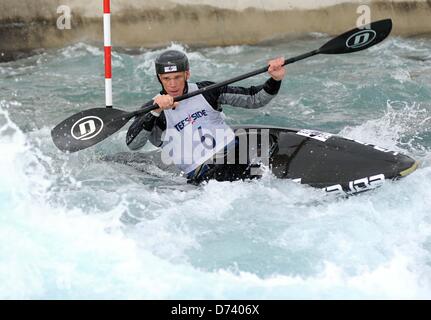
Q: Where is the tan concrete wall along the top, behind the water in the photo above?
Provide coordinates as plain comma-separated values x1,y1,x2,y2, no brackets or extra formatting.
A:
0,0,431,60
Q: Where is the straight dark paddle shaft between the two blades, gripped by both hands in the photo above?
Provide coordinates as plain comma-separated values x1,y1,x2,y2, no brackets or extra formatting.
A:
129,49,320,118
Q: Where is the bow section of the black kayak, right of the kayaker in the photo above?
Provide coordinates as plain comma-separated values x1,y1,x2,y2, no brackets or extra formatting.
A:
232,125,418,194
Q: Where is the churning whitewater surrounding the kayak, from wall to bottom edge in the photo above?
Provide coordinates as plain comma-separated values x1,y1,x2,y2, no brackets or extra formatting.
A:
0,37,431,299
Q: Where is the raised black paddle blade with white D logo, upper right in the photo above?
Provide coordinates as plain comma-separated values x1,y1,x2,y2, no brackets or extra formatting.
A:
319,19,392,54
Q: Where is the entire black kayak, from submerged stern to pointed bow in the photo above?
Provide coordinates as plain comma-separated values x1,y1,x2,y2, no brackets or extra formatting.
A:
102,125,418,195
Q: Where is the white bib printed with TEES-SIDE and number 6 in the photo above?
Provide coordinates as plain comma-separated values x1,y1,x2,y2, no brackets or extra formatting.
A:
162,83,235,173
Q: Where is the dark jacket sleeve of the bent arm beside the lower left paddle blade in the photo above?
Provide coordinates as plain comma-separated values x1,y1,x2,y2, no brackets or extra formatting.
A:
126,101,166,150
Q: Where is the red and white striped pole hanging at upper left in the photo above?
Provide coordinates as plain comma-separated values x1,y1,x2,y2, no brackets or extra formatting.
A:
103,0,112,108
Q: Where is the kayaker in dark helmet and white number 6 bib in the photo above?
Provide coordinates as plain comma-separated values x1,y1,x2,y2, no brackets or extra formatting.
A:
126,50,286,183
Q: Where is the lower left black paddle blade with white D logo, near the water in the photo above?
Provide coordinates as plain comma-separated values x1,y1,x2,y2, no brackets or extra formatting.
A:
51,108,133,152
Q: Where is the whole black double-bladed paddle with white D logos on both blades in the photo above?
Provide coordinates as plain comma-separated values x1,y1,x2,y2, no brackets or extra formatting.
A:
51,19,392,152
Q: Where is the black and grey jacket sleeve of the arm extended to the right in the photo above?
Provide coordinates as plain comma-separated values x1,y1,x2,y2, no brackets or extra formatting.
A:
198,78,281,111
